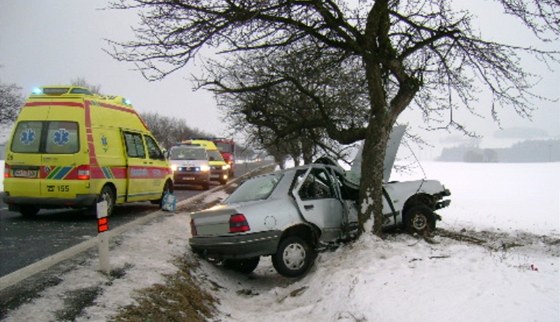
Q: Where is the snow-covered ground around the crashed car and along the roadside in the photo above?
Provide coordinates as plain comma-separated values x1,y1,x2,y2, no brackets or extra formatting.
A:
2,162,560,322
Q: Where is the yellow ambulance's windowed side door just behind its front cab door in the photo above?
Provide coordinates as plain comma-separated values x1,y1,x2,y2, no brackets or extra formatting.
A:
123,131,153,201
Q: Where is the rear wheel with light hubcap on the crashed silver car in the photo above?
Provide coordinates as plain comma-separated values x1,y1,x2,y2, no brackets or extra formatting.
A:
272,236,315,277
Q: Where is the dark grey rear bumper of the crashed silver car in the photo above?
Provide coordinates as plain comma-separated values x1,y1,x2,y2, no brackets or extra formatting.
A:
189,230,282,259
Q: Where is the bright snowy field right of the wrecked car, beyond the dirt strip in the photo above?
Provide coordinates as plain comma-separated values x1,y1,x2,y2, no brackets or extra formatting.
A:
391,162,560,234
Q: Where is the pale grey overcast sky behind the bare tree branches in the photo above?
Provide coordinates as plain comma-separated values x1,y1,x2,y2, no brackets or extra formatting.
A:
0,0,560,148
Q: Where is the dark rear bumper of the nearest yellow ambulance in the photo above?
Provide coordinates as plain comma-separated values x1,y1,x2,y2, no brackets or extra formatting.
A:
2,193,98,210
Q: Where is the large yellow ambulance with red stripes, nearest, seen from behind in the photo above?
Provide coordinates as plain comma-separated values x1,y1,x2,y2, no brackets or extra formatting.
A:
3,86,173,216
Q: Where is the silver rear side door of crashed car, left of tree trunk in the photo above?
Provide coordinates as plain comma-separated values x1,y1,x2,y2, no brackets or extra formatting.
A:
292,167,345,241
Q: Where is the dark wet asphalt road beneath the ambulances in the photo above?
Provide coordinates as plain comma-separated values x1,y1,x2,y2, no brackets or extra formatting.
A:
0,164,272,277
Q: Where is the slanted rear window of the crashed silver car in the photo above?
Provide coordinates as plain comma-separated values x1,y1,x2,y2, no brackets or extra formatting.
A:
227,173,282,203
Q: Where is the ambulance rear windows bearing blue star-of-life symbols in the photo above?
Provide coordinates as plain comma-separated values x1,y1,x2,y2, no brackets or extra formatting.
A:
11,121,80,154
